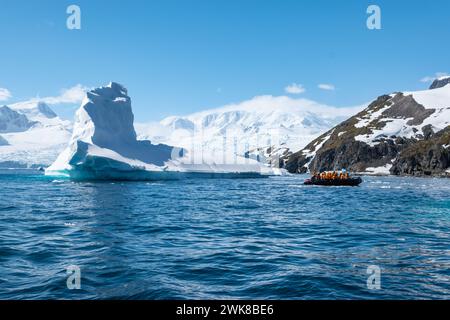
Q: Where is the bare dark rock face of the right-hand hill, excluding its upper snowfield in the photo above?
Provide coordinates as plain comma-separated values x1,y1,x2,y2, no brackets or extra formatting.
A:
285,89,450,175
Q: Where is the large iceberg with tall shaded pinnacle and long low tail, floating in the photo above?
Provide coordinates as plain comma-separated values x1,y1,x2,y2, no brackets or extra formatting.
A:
45,82,277,180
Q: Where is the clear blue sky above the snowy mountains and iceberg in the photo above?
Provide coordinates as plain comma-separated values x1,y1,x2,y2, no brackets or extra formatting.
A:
0,0,450,121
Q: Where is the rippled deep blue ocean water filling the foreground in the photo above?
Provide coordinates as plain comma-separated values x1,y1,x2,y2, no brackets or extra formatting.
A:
0,170,450,299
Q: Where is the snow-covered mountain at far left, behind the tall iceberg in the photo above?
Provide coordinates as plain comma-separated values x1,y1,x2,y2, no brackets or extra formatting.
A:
0,100,72,168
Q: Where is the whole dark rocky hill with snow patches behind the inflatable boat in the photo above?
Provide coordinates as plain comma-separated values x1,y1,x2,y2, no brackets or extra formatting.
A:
286,77,450,175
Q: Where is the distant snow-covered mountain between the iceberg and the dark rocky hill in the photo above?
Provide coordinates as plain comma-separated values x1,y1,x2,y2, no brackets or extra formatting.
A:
137,96,362,166
